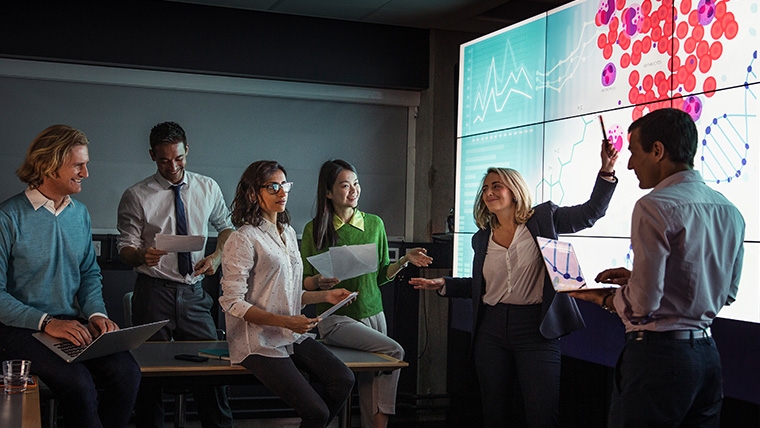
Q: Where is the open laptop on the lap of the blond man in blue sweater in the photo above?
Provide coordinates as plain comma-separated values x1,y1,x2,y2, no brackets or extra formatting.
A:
32,320,169,363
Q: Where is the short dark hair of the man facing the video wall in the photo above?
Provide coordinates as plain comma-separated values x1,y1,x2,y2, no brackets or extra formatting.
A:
628,108,698,168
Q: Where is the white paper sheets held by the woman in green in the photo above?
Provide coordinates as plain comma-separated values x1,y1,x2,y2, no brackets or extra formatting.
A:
306,244,377,281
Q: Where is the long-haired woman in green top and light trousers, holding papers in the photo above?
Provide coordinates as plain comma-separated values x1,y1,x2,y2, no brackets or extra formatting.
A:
301,159,433,428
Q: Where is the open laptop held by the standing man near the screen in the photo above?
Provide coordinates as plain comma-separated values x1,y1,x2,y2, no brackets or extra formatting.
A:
536,236,620,293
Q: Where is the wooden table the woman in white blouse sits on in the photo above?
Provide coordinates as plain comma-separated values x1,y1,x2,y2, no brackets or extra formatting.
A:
132,341,409,428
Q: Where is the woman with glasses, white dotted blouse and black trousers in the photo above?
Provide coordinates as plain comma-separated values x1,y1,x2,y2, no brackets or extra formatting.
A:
219,161,354,428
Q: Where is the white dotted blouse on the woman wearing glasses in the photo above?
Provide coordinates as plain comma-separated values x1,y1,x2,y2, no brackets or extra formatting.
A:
219,220,305,363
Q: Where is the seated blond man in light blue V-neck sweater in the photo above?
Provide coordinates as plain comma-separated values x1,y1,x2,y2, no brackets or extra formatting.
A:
0,125,140,428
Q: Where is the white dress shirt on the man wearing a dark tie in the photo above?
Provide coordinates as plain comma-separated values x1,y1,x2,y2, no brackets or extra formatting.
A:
116,171,233,284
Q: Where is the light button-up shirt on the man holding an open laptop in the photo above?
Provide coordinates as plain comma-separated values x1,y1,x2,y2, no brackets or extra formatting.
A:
614,170,745,331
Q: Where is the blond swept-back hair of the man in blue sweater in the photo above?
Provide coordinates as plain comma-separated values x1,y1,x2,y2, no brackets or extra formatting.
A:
16,125,89,189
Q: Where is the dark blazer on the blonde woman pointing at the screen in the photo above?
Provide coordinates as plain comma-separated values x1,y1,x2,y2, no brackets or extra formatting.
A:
444,177,617,346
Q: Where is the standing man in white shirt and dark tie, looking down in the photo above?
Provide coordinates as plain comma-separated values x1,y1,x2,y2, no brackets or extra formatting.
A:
117,122,233,428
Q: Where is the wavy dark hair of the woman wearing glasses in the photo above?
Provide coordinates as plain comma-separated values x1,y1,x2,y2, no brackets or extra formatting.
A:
230,161,290,228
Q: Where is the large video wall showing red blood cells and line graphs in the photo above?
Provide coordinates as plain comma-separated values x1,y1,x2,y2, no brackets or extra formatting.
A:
454,0,760,322
